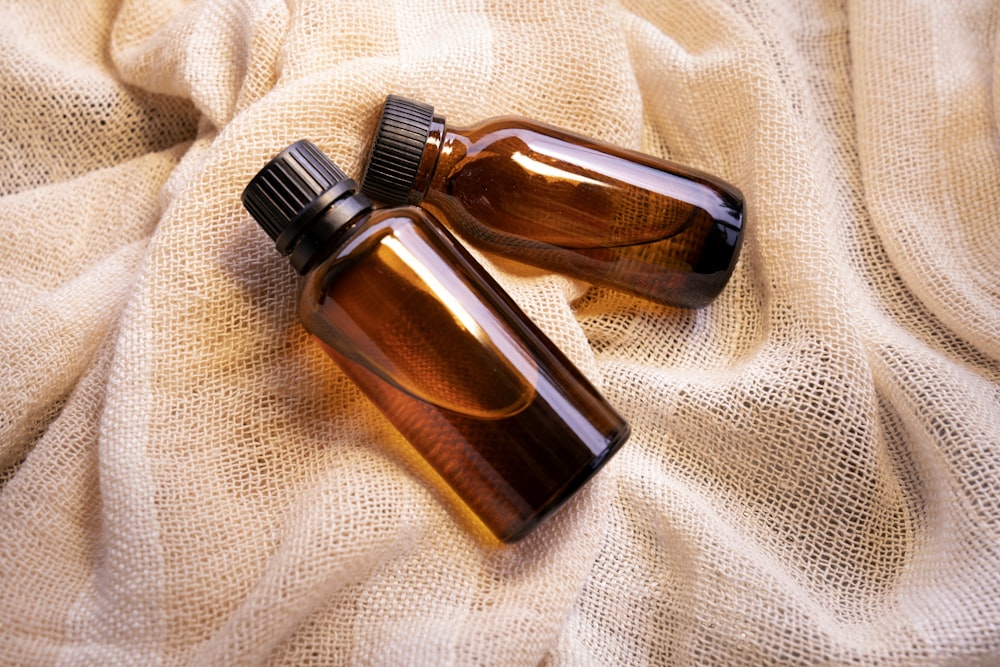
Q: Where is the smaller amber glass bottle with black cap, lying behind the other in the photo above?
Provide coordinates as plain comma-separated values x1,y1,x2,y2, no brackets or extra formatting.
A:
362,95,743,308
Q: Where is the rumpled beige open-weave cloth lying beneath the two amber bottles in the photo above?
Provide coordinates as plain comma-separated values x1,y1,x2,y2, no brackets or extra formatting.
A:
0,0,1000,666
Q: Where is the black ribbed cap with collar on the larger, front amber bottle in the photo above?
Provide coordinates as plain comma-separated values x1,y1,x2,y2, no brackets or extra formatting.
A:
241,139,371,272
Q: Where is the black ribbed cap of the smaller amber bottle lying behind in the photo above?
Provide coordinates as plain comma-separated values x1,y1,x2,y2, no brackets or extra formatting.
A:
361,95,434,206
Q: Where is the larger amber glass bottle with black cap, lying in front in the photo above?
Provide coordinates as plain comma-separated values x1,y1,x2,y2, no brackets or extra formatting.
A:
243,141,629,542
